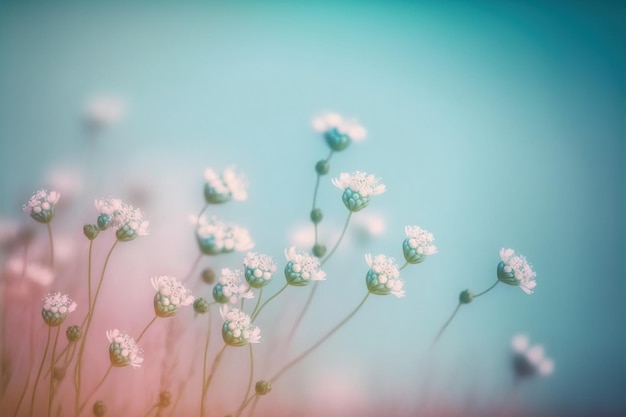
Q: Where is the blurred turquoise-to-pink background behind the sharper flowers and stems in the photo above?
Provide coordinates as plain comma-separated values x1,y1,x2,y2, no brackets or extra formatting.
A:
0,0,626,416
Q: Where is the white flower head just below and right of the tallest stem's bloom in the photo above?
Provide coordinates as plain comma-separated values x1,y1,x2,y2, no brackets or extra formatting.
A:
332,171,385,212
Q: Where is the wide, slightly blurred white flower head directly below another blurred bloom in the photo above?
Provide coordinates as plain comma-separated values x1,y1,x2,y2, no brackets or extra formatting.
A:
196,217,254,255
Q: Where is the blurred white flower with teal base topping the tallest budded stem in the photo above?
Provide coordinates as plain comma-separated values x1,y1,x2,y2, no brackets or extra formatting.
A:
313,113,367,151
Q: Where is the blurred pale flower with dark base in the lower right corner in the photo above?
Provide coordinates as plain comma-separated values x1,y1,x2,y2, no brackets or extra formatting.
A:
511,334,554,378
